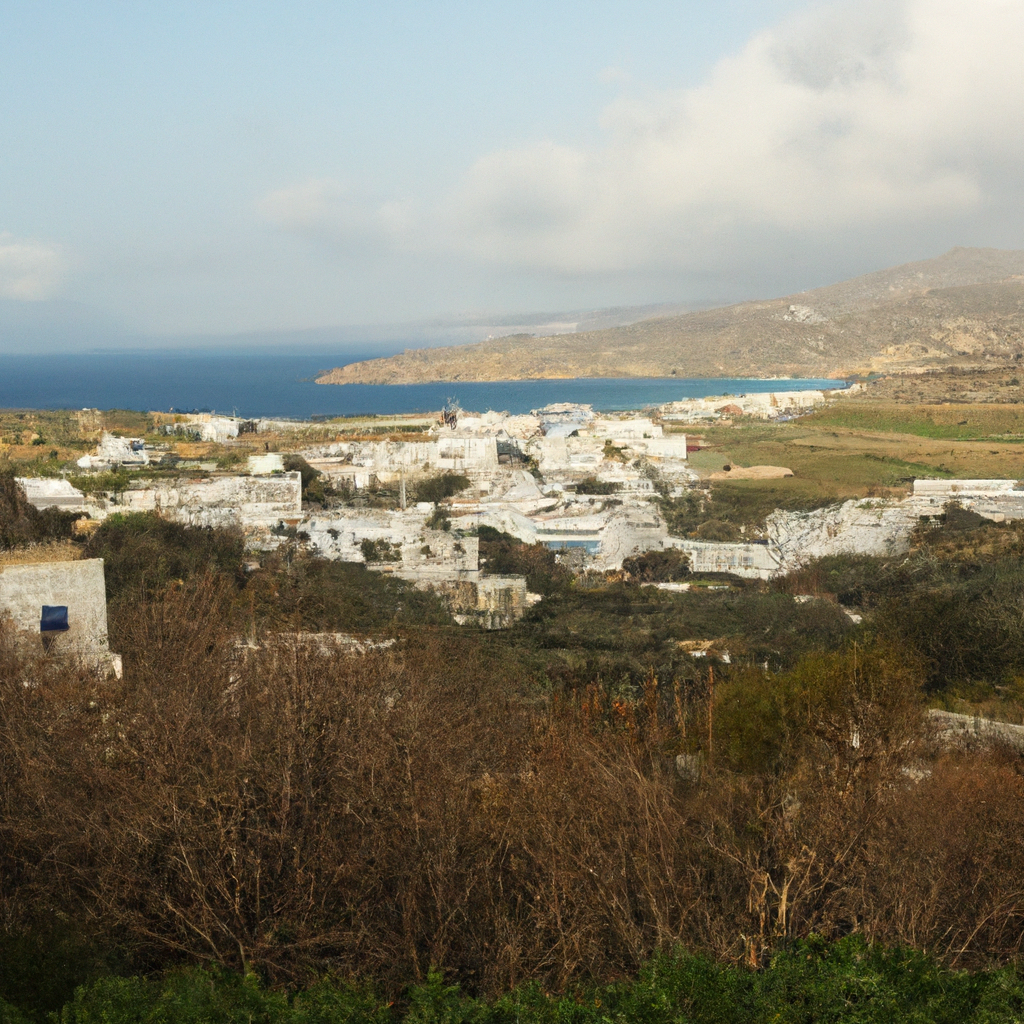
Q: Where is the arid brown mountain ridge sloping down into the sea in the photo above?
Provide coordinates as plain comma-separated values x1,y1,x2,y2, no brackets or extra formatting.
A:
318,248,1024,384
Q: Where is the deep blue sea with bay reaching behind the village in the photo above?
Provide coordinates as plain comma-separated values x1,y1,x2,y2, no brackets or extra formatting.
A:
0,351,843,420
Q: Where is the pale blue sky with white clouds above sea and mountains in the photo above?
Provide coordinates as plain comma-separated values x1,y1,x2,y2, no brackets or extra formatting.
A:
0,0,1024,346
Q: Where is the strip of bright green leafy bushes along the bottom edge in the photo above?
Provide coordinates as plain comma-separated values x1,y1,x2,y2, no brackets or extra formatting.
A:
39,936,1024,1024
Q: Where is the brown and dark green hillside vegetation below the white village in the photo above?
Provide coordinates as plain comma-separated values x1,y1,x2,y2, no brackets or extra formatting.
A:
0,493,1024,1007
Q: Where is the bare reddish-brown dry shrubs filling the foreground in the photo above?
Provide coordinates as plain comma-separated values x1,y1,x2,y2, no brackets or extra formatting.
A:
0,598,1024,992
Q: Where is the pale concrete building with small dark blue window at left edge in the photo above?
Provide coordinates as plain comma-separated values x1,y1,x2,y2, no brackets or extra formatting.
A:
0,558,121,676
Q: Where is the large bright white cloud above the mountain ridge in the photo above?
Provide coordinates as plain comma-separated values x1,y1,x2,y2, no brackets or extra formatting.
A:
449,0,1024,273
